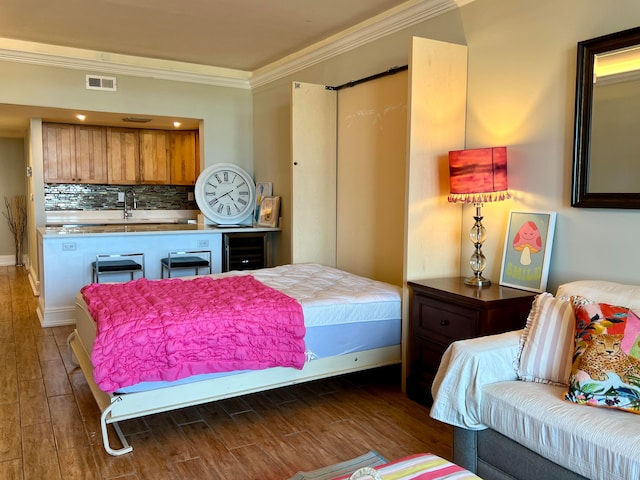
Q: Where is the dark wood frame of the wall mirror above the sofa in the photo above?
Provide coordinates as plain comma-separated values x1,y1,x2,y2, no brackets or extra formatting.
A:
571,27,640,209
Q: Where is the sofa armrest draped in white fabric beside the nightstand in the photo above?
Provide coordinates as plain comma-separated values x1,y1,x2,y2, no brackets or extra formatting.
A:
430,330,522,430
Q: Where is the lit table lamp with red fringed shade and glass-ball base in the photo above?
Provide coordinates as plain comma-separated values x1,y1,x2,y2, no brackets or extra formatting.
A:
448,147,511,287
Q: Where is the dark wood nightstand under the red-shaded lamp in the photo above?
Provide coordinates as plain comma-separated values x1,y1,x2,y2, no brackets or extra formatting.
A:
407,277,537,405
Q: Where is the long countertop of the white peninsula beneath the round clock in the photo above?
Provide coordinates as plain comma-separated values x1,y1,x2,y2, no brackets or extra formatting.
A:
38,223,280,238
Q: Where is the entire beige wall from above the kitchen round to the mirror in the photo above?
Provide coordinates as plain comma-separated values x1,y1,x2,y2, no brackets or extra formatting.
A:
5,0,640,289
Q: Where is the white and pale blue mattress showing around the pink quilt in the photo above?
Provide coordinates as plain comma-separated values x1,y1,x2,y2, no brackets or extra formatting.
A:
76,264,402,393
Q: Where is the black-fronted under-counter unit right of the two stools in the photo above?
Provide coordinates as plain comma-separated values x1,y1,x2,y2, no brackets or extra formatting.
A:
222,232,269,272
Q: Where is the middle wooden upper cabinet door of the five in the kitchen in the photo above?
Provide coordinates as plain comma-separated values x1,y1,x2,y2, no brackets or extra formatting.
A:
107,128,140,185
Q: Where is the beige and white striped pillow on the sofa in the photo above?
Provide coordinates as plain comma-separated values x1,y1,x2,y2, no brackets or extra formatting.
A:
517,292,576,385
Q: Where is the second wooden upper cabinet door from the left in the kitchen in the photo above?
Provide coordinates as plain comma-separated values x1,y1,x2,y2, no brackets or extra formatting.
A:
75,125,107,183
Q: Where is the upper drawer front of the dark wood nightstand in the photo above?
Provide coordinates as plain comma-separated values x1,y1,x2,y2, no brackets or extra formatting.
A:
413,296,478,344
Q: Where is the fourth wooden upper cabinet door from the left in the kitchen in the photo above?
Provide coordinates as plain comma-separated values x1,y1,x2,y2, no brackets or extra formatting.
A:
139,130,170,185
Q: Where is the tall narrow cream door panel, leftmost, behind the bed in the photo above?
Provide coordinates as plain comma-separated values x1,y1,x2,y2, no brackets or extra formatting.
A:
291,82,336,267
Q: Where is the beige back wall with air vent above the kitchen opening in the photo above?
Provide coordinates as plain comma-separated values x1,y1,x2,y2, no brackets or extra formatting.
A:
0,62,253,172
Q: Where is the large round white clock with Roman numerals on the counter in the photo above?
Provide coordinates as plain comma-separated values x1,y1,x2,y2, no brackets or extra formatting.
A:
195,163,256,225
